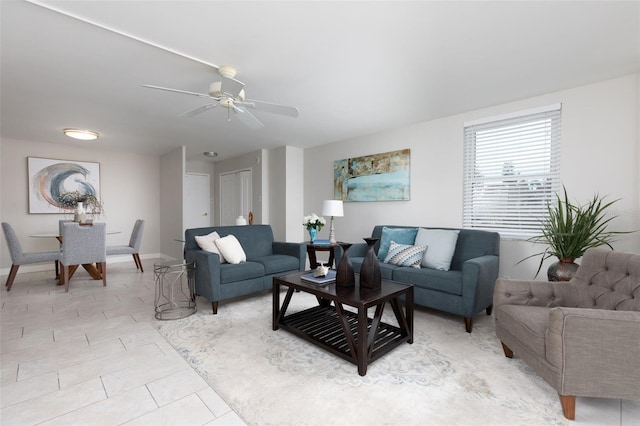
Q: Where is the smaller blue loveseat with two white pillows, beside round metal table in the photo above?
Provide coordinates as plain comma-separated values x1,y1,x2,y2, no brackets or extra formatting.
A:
184,225,307,314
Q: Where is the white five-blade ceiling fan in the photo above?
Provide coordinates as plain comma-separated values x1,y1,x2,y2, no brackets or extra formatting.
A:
142,65,298,129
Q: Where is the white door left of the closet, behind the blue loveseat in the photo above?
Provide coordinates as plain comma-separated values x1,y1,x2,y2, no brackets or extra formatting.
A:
183,173,211,229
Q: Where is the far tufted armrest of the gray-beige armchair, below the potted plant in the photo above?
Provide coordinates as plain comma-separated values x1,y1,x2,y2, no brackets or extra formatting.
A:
493,278,578,308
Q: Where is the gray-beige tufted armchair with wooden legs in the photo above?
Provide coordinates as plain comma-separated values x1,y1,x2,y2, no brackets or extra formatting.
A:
493,249,640,420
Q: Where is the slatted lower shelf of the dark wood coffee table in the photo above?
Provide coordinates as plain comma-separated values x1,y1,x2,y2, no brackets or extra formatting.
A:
278,305,409,365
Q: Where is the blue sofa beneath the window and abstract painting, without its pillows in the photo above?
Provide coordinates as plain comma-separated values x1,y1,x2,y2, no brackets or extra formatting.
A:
335,225,500,333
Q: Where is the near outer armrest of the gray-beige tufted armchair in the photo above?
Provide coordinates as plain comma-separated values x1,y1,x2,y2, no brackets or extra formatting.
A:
545,307,640,399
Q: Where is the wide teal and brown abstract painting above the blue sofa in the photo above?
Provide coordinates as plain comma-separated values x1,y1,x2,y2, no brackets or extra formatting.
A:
333,149,411,201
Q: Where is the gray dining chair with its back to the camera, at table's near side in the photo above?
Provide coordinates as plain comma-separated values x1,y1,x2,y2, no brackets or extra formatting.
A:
59,222,107,292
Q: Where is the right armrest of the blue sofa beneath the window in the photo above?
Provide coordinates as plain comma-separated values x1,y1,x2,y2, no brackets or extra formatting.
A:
462,255,500,317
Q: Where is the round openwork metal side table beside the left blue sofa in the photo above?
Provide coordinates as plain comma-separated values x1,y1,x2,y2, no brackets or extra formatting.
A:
153,259,196,320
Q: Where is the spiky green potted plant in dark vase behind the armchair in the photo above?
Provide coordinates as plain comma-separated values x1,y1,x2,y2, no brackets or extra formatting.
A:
518,187,631,281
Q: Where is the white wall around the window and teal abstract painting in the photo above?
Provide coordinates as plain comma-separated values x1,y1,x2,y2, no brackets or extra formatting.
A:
304,74,640,279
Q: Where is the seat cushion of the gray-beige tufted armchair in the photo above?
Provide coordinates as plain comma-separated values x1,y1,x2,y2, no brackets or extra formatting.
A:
496,305,551,358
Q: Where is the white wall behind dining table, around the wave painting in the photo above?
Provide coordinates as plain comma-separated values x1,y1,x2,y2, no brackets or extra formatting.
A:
0,139,161,274
